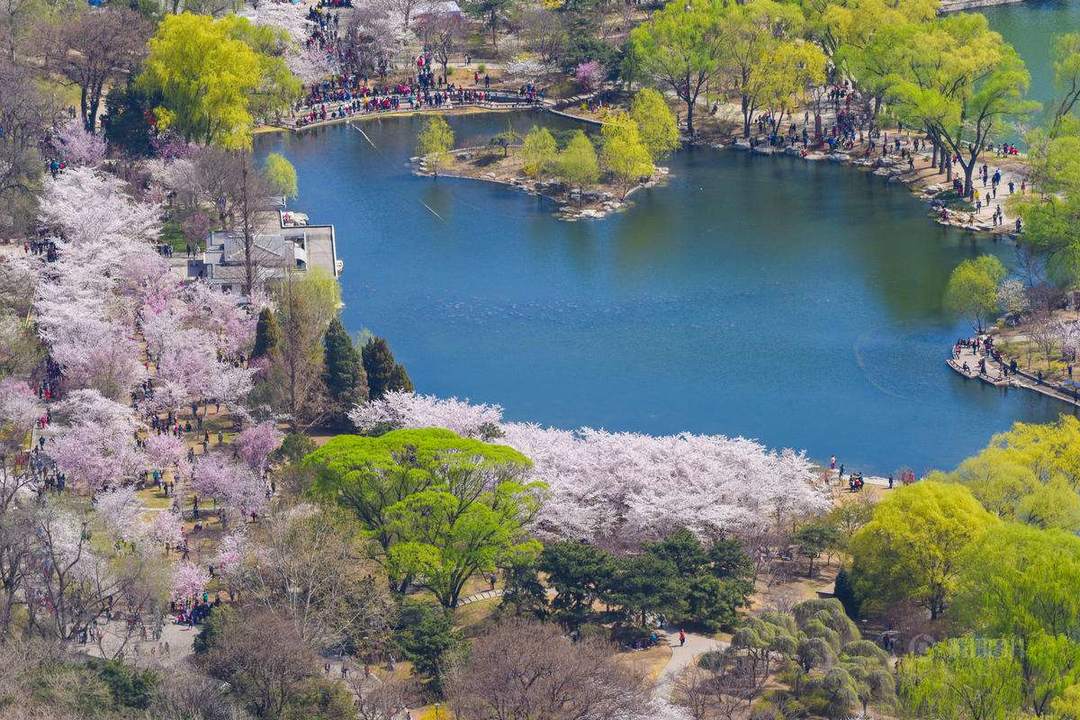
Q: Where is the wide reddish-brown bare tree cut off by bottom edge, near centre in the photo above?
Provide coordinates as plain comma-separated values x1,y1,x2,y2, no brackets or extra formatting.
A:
447,620,656,720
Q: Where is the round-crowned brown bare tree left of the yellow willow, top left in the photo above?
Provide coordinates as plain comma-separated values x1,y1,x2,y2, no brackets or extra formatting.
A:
49,5,150,133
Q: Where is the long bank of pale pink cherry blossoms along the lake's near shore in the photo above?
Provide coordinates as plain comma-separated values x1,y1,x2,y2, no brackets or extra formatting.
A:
350,393,828,542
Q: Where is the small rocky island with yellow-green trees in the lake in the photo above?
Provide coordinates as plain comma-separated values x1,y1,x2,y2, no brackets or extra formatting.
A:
413,91,679,219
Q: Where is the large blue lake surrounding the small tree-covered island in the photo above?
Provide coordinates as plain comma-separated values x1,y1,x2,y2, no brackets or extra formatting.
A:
258,114,1062,473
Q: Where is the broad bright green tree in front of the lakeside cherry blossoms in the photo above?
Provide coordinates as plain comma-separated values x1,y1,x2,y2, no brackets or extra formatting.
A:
305,427,546,608
